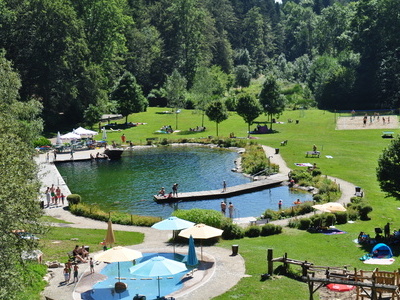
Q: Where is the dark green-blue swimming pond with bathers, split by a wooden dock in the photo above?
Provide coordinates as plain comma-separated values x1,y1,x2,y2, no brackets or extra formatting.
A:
57,147,312,218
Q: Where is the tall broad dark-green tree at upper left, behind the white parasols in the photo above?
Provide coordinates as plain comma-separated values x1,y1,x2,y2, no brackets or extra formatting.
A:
0,0,97,130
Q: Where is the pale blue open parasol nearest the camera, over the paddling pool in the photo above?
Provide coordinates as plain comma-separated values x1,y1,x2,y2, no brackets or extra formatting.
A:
129,256,187,297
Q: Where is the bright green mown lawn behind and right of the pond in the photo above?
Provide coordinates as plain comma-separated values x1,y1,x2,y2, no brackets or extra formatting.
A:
90,108,400,300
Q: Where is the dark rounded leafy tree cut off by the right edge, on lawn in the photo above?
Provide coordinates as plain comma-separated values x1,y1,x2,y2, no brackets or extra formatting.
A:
376,136,400,199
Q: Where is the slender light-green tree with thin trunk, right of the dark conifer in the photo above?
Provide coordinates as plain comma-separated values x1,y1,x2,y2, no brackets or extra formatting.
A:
164,69,187,129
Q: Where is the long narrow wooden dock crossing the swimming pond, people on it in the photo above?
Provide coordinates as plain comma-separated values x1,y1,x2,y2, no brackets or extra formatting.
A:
154,174,287,203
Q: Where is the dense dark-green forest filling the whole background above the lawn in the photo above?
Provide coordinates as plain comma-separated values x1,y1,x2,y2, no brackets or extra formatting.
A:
0,0,400,130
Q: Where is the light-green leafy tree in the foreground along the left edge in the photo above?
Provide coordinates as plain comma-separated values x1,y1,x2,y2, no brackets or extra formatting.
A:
0,48,44,300
